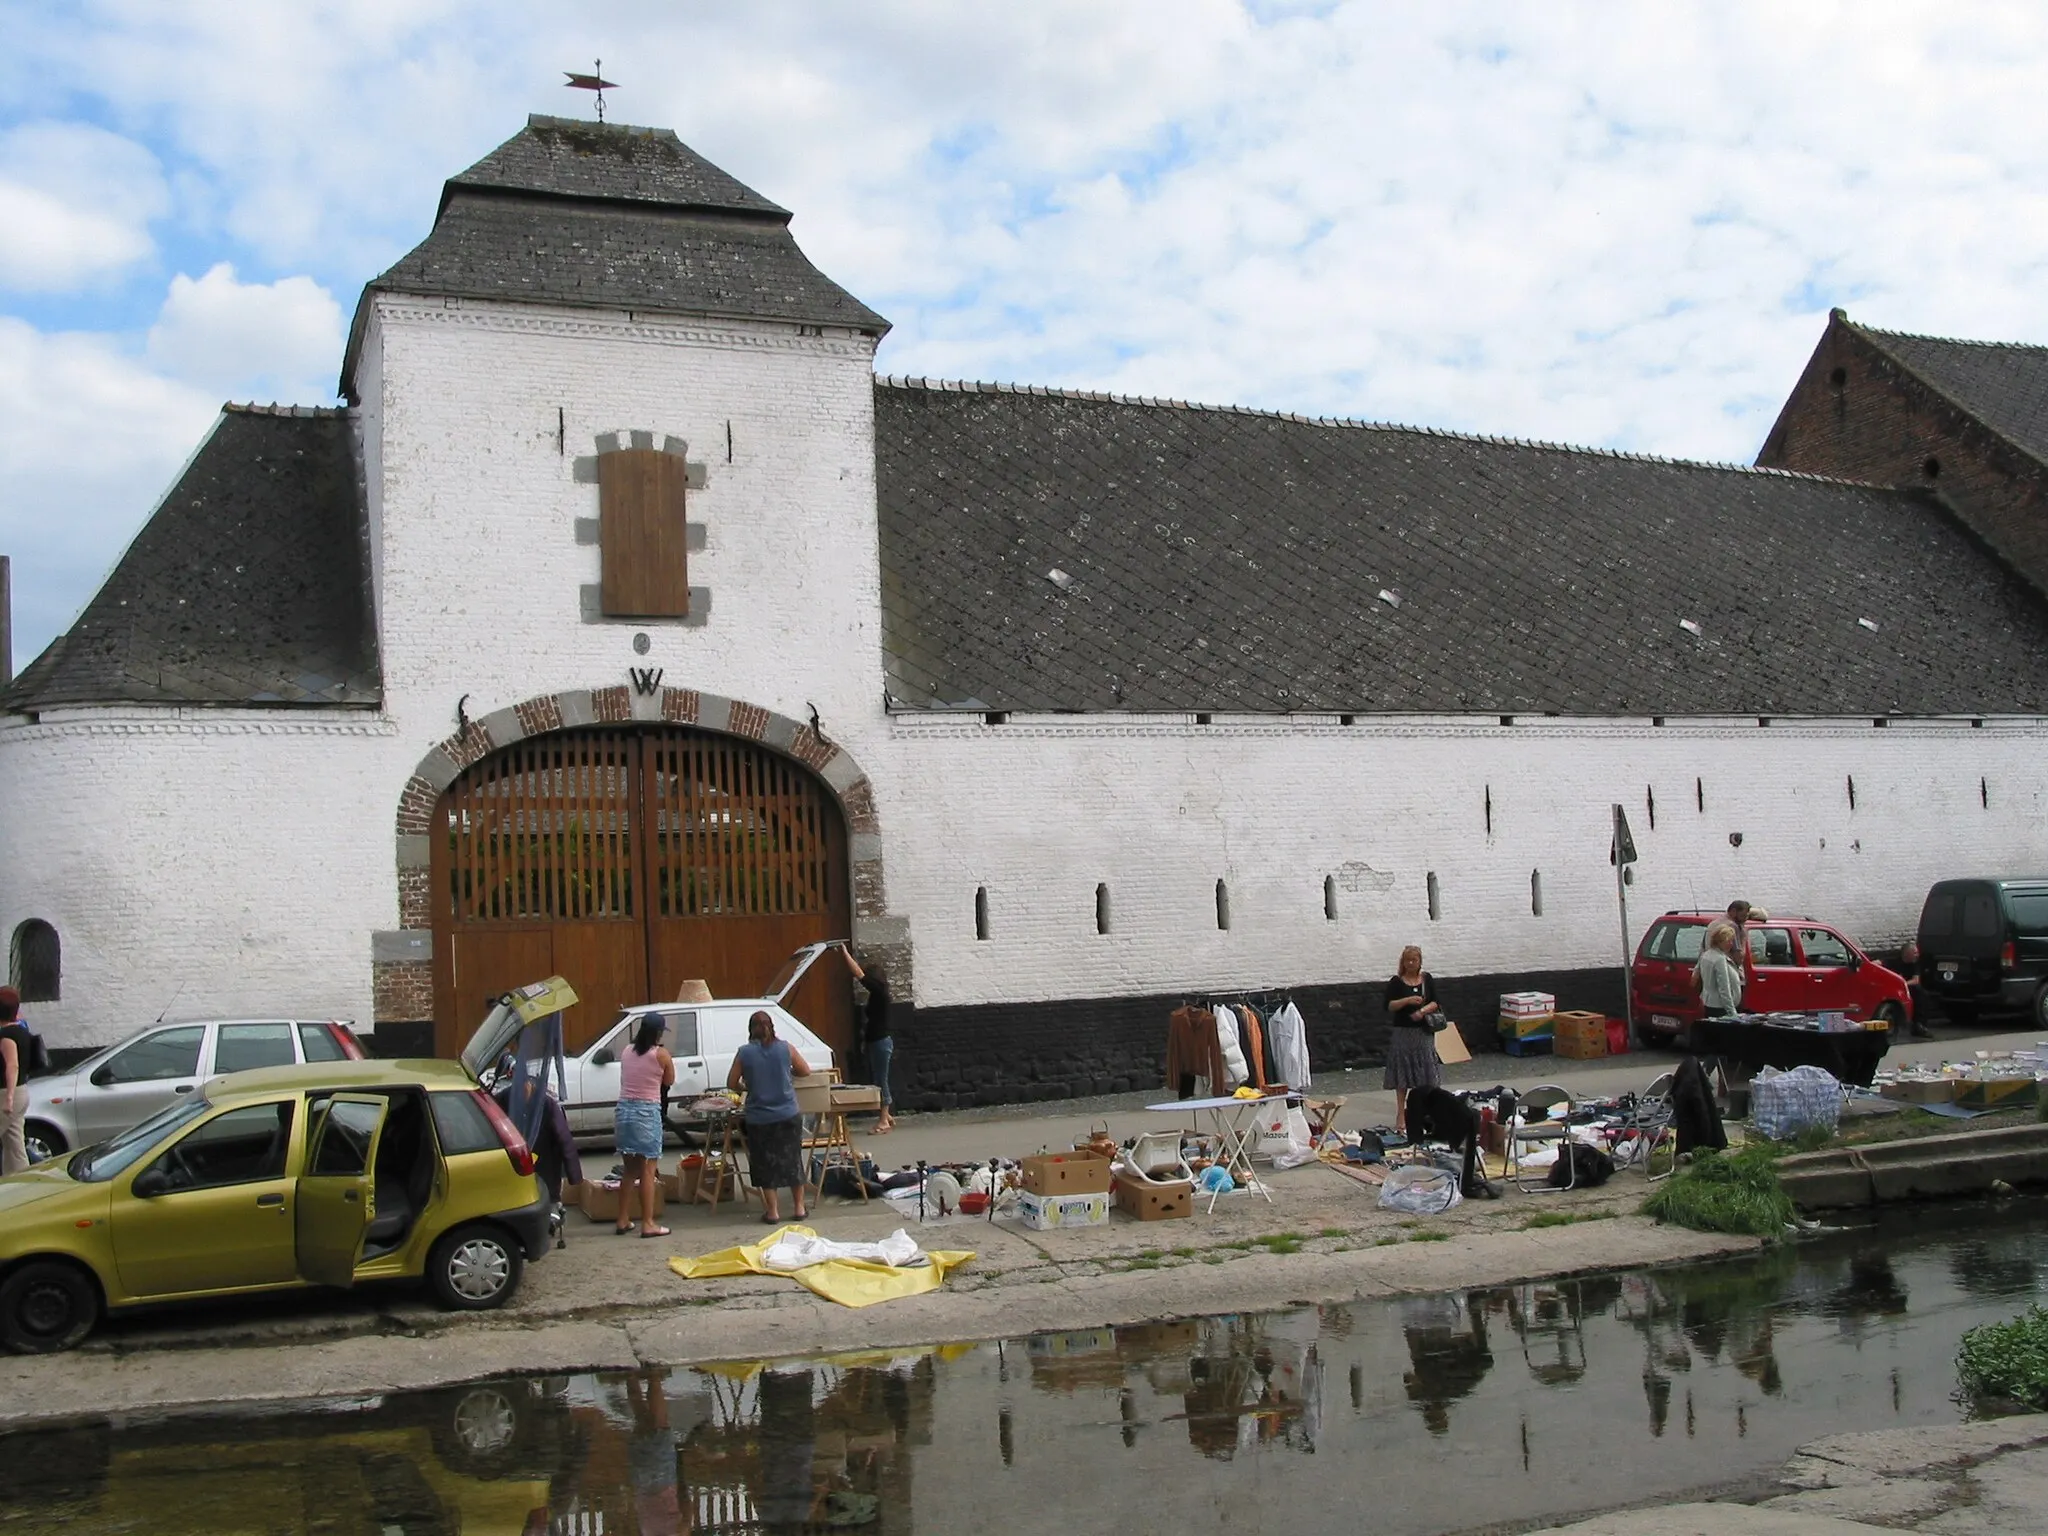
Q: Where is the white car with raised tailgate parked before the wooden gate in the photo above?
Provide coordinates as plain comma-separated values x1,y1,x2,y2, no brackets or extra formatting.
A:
463,942,840,1137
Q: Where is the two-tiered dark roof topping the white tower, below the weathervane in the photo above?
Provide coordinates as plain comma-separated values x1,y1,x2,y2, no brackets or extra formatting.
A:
342,117,889,399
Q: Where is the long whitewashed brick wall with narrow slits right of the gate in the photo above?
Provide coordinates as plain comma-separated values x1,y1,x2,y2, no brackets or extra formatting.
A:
872,717,2048,1006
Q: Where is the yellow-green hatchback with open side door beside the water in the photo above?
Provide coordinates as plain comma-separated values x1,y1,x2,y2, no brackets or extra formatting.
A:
0,1061,559,1354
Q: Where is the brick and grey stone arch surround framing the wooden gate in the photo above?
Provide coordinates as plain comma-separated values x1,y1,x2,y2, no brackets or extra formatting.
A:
371,684,913,1049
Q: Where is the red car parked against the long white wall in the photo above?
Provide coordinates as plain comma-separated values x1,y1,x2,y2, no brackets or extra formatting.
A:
1628,911,1909,1047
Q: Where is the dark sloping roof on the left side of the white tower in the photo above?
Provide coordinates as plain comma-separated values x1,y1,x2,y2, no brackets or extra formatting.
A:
0,406,383,713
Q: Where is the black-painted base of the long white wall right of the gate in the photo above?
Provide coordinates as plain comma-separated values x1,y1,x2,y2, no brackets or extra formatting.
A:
888,969,1624,1110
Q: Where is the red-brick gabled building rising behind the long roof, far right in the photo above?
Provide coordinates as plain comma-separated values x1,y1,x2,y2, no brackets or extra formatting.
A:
1757,309,2048,594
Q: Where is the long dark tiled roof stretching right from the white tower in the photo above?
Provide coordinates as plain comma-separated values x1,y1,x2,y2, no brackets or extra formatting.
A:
874,379,2048,717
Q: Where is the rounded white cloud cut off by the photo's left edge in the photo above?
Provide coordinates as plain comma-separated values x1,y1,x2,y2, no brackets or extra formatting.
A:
0,123,168,293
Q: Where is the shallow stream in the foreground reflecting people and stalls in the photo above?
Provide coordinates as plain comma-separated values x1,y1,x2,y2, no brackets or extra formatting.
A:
0,1204,2048,1536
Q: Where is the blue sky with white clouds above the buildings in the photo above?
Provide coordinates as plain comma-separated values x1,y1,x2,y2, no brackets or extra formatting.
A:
0,0,2048,666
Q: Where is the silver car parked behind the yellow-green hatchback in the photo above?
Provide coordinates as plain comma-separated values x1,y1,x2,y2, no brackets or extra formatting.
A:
23,1018,369,1163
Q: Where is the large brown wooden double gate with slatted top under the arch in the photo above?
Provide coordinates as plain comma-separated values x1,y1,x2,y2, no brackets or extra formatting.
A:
430,725,852,1059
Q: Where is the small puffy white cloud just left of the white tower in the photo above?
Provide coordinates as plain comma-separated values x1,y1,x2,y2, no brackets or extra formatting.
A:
147,262,342,406
